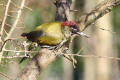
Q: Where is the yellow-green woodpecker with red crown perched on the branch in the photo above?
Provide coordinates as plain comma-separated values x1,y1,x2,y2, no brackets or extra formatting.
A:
20,21,88,62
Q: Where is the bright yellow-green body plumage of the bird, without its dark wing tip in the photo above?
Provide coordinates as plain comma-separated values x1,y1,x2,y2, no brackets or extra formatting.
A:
36,22,63,45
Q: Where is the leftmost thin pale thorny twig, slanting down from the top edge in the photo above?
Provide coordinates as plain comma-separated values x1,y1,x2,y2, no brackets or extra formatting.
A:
0,0,11,40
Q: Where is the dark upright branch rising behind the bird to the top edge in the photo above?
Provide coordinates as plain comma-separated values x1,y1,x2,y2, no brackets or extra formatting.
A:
54,0,71,22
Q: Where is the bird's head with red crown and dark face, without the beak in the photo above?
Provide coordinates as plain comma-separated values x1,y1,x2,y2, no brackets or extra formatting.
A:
61,21,80,34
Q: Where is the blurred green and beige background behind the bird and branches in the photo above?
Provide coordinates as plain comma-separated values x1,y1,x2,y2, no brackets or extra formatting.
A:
0,0,120,80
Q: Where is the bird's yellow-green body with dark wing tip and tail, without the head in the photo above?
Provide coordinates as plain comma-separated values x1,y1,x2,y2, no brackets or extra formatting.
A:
23,22,63,45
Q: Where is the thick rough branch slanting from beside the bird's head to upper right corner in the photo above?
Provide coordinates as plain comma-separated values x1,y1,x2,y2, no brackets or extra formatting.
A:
78,0,120,31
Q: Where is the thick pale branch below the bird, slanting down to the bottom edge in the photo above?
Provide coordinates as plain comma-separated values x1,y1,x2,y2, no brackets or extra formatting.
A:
16,49,56,80
